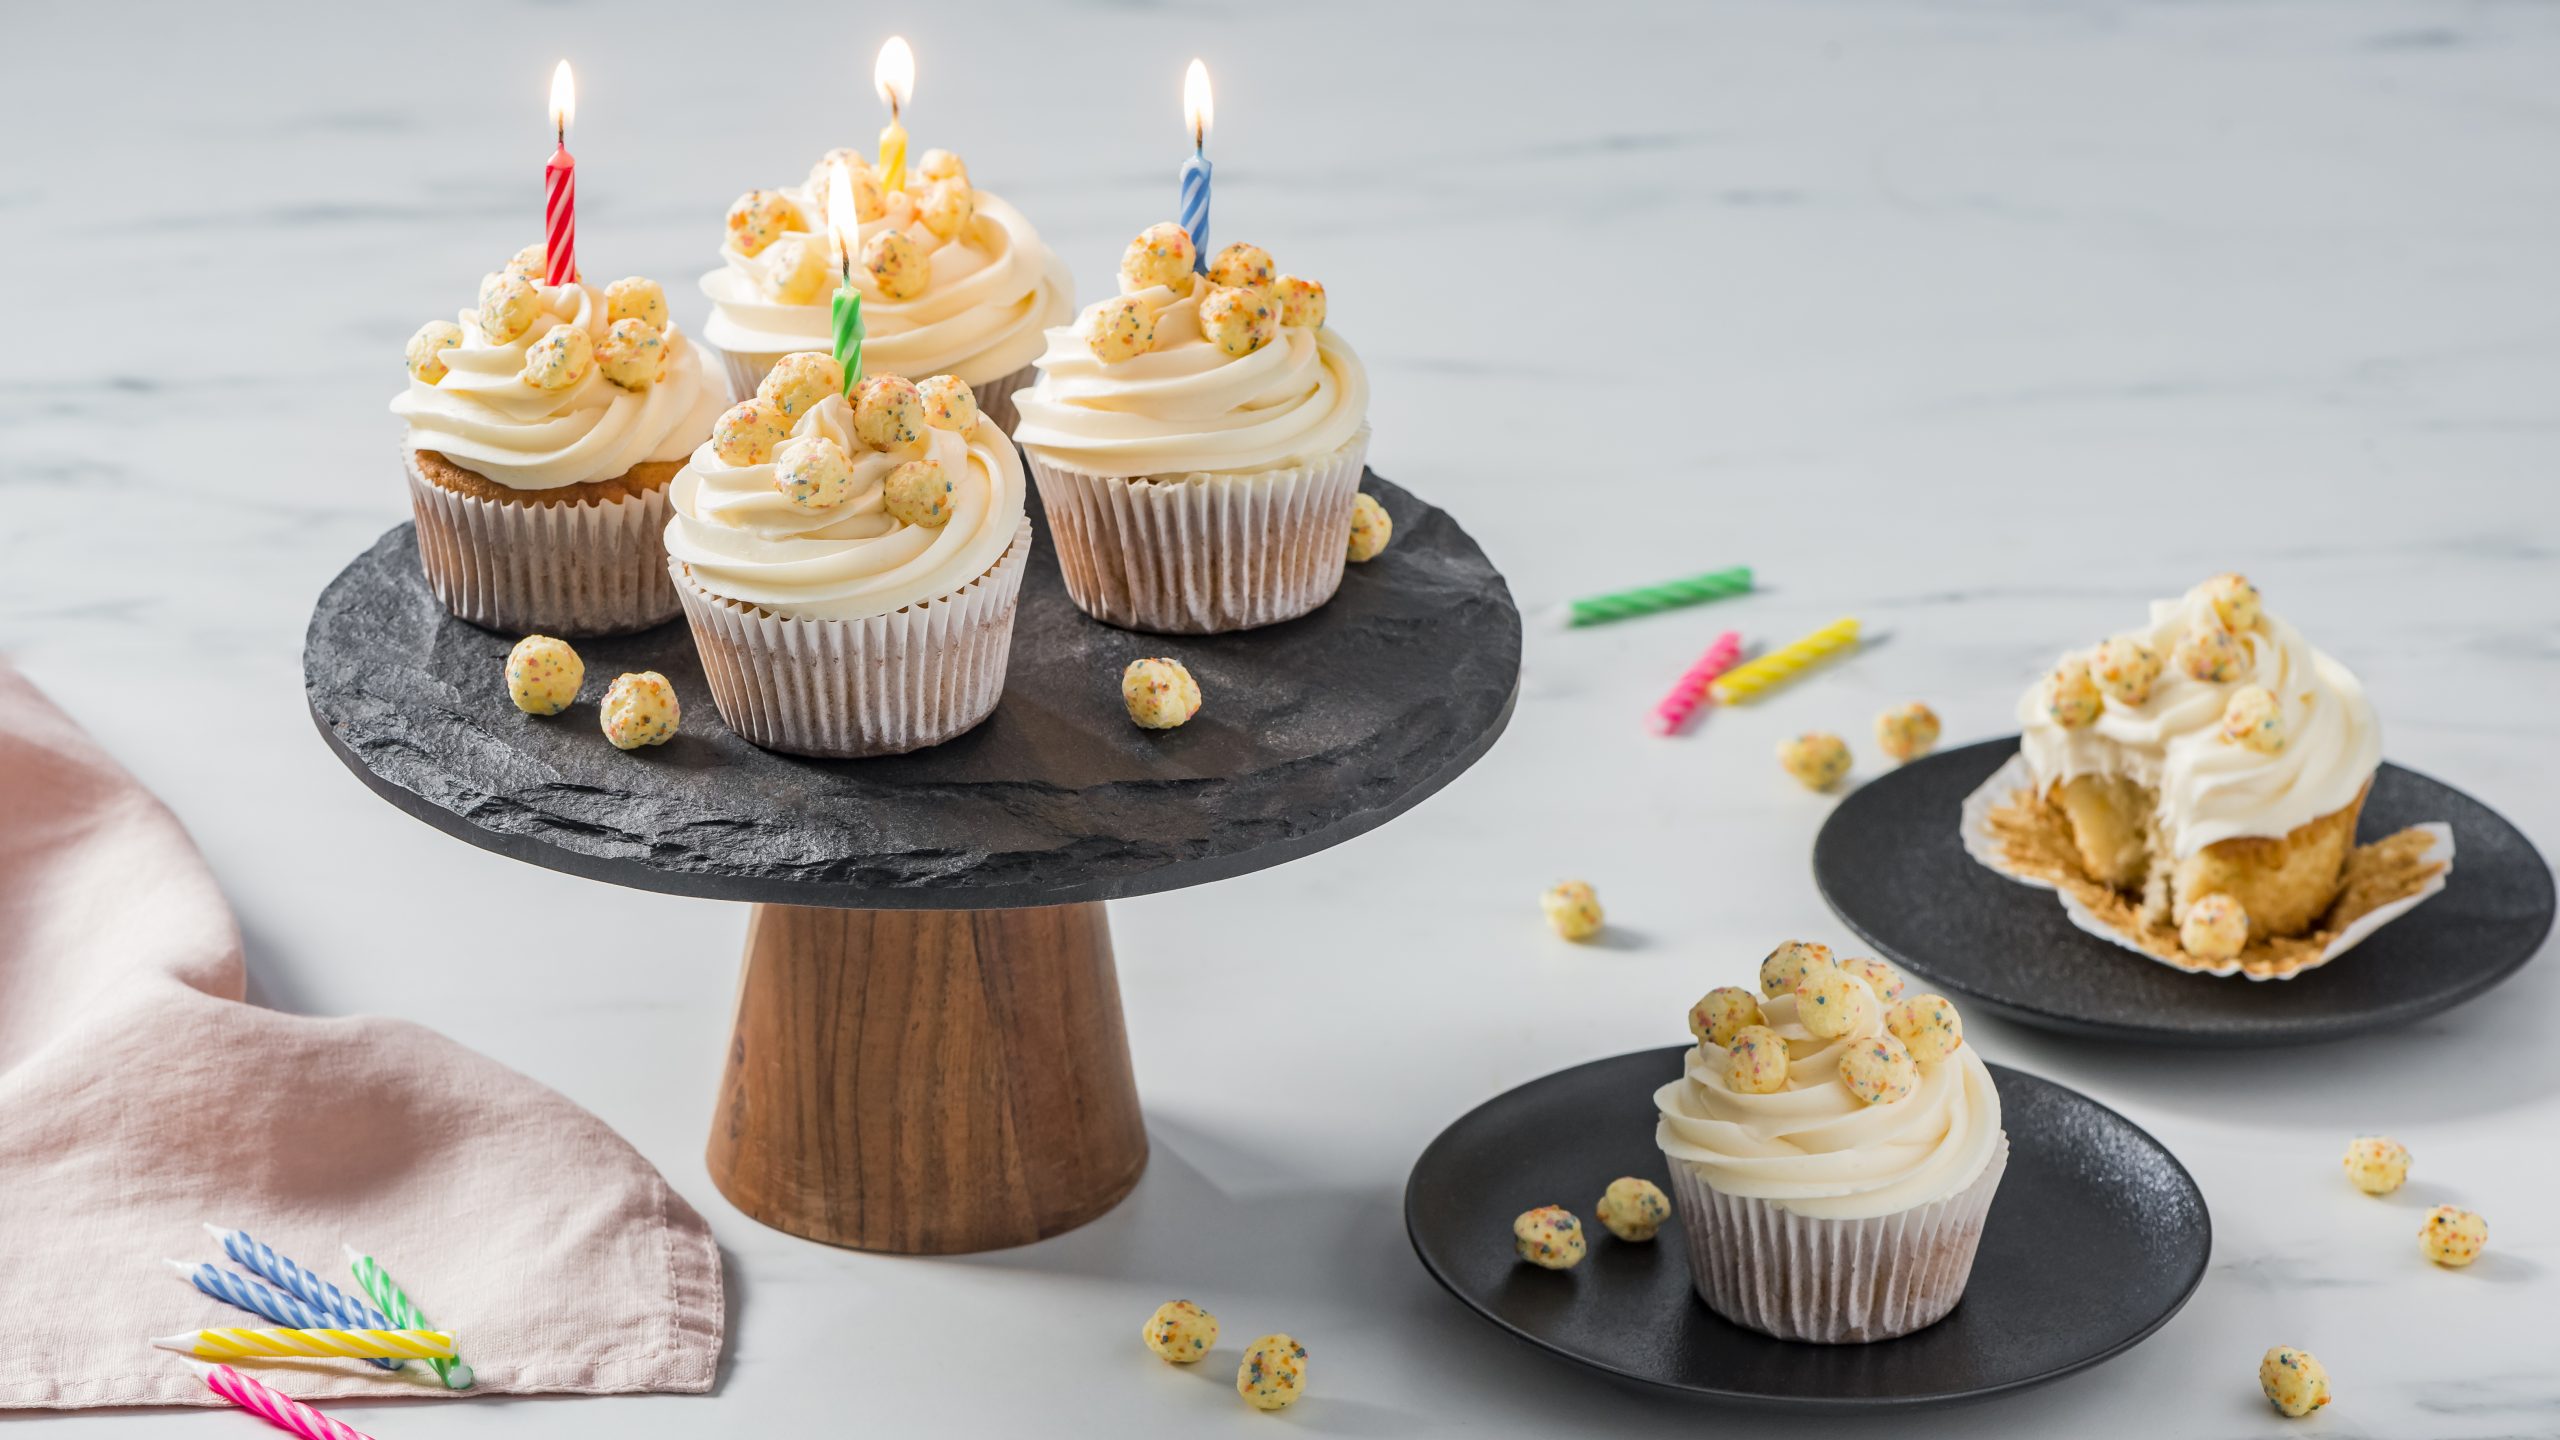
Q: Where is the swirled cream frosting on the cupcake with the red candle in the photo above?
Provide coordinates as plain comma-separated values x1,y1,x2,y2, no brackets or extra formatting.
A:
392,282,727,489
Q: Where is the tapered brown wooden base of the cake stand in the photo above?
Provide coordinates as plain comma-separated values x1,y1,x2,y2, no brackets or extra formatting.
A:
709,902,1147,1256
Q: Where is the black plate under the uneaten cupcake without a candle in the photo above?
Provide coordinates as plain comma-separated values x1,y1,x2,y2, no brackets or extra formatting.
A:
1405,1045,2212,1412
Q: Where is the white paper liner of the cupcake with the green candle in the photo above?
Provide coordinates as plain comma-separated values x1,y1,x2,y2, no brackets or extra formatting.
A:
666,518,1032,758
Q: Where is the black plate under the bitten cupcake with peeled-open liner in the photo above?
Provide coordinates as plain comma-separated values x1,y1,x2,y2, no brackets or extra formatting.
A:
1812,735,2552,1045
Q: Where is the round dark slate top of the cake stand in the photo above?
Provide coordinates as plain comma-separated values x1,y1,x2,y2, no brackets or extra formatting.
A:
302,474,1521,910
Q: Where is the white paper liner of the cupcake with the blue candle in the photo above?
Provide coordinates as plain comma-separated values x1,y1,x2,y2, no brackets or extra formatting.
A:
1024,425,1370,635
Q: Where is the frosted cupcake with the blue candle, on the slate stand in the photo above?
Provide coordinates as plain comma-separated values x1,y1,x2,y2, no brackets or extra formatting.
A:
1014,220,1370,635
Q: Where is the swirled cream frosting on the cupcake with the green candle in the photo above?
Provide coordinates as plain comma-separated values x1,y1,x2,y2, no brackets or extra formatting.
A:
666,395,1021,620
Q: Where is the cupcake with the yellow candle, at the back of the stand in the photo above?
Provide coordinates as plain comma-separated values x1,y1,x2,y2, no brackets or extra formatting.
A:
701,149,1075,430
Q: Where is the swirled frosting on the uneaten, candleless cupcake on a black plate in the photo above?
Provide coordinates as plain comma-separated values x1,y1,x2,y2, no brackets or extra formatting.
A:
1654,994,1999,1220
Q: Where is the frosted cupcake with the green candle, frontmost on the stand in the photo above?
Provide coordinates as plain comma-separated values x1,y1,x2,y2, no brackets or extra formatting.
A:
666,354,1032,756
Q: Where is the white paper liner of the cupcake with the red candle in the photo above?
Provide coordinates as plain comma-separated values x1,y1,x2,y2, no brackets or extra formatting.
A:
402,448,678,638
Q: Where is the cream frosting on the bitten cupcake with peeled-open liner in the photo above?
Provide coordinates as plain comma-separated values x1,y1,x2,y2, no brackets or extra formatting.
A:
2017,584,2383,858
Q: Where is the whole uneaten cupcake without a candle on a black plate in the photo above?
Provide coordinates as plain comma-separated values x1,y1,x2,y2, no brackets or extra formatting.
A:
1654,943,2010,1345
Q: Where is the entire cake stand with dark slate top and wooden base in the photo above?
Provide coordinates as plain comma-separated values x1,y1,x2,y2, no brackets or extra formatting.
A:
302,474,1521,1253
